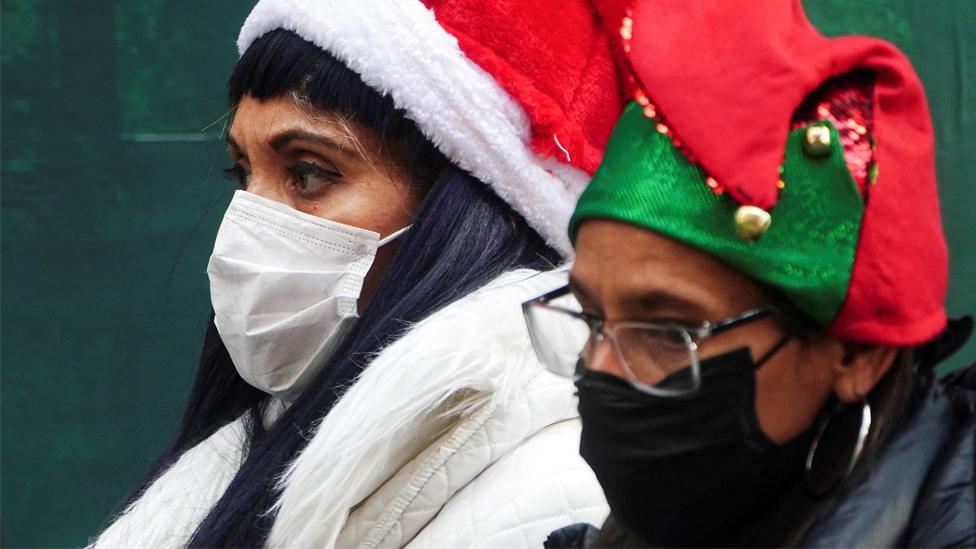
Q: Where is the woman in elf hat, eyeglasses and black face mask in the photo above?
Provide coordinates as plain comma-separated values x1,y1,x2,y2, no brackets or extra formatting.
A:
525,0,976,547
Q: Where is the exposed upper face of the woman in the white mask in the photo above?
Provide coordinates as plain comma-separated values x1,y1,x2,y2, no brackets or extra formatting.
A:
227,95,420,307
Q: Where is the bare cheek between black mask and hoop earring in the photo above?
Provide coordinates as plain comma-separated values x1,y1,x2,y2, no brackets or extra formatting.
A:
756,342,832,444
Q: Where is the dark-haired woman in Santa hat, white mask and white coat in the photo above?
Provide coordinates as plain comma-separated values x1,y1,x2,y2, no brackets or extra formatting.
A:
94,0,619,547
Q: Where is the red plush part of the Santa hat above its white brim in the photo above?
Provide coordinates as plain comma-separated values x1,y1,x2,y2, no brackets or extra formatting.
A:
423,0,623,174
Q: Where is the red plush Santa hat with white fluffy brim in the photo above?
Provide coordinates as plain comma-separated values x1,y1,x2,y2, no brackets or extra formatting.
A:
237,0,622,256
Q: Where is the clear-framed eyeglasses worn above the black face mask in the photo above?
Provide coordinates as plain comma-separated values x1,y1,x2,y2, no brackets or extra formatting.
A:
522,286,776,396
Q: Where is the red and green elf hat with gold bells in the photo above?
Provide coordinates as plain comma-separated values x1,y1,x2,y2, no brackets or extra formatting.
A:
570,0,948,346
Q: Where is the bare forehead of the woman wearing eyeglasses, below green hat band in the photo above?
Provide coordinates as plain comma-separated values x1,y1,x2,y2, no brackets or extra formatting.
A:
573,219,764,314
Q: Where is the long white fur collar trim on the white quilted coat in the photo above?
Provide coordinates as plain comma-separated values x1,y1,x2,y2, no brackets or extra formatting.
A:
269,271,565,547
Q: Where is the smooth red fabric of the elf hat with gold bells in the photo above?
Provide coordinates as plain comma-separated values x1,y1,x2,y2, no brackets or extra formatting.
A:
630,0,948,345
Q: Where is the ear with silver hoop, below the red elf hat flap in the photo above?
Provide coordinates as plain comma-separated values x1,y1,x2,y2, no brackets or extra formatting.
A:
833,341,898,403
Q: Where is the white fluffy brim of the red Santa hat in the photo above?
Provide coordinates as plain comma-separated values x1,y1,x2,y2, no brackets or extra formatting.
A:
237,0,589,257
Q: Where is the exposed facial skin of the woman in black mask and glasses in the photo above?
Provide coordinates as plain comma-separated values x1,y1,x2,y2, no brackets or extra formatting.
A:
570,220,844,444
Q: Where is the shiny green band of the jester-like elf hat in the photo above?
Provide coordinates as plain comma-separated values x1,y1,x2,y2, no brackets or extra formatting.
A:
569,103,864,325
